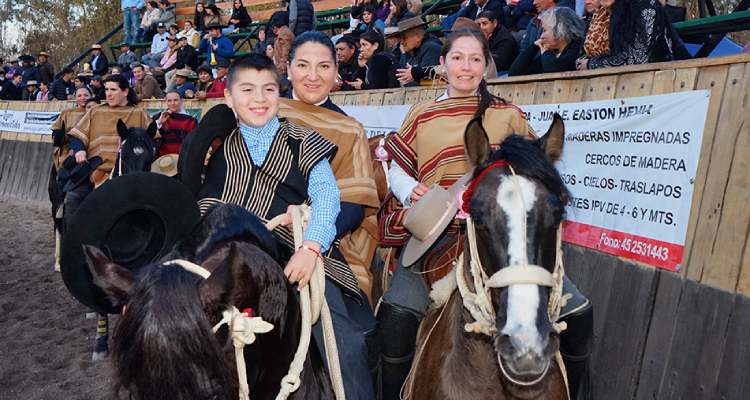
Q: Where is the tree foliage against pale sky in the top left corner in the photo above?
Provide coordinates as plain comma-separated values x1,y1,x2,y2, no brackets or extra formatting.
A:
0,0,123,69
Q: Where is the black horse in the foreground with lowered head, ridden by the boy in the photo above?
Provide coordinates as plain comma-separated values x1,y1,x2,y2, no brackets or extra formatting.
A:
84,205,334,400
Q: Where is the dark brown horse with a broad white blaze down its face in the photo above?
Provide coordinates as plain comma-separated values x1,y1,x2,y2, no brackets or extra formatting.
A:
406,117,568,400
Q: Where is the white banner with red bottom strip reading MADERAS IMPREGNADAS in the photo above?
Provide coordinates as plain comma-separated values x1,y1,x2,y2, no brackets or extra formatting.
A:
344,91,709,270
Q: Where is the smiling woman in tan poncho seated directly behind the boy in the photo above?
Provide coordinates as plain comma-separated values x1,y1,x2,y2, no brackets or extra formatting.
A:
279,31,380,397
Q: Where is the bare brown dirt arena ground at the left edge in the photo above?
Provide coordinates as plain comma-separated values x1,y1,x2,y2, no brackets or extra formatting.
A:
0,199,112,400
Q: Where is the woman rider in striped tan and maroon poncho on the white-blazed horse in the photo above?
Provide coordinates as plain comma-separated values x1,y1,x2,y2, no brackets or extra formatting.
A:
378,30,591,400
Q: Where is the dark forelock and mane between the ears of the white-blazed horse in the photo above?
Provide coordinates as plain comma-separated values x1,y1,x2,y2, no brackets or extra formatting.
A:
488,135,570,207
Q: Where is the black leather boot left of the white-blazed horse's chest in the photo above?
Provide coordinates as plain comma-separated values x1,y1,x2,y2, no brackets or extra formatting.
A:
378,302,420,400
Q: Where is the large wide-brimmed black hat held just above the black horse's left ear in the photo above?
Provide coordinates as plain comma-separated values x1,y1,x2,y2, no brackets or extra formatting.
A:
60,172,200,314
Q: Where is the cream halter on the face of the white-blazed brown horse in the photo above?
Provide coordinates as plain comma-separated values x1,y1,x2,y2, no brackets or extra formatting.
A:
456,160,565,386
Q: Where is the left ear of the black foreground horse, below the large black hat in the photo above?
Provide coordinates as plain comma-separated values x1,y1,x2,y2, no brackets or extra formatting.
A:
83,244,133,306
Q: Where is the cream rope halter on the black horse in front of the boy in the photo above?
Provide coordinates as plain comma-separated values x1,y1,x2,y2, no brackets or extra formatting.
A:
162,260,273,400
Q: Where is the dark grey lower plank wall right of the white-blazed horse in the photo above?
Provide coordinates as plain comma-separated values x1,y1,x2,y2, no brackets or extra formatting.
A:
564,245,750,400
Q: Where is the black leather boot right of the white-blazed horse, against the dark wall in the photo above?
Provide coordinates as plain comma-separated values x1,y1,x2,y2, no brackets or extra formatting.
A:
560,302,594,400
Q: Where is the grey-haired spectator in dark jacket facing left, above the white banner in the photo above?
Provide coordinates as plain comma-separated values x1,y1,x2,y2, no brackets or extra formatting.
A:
508,7,585,76
